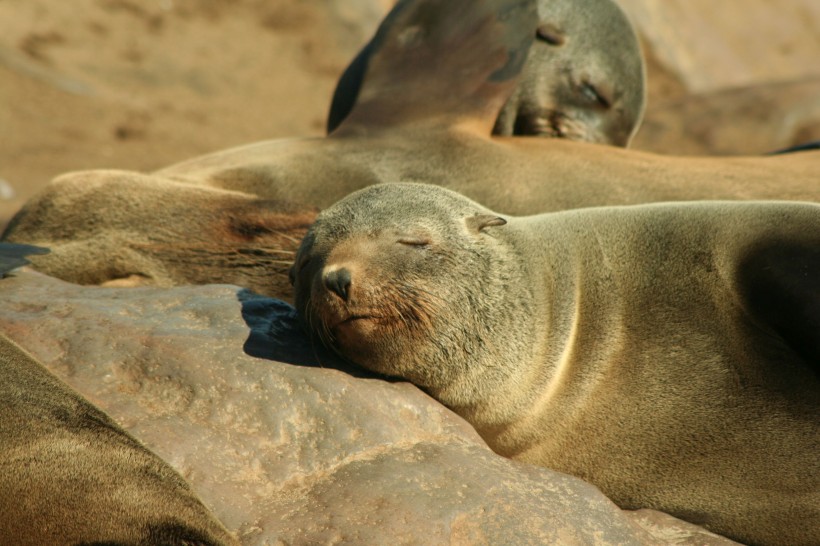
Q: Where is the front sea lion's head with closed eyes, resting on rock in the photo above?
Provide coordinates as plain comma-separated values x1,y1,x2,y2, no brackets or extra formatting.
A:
291,184,527,393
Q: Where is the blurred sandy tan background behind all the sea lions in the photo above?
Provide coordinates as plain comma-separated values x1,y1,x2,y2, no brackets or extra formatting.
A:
0,0,820,227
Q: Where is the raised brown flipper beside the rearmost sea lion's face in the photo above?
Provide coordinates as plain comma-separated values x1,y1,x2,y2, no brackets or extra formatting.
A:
329,0,538,135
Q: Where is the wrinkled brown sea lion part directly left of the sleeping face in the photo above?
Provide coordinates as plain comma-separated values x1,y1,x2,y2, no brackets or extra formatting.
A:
4,171,318,294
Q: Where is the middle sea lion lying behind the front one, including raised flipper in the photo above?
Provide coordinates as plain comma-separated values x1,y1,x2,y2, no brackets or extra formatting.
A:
3,0,820,299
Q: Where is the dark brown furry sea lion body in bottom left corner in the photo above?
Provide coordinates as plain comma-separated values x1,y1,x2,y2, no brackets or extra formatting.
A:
0,328,238,546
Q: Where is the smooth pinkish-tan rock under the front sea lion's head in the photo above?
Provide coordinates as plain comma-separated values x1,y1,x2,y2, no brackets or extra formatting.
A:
0,271,733,545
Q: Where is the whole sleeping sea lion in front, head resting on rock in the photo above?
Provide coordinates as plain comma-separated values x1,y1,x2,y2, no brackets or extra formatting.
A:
292,184,820,546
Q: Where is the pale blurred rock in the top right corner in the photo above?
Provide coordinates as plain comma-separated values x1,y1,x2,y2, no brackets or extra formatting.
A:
618,0,820,93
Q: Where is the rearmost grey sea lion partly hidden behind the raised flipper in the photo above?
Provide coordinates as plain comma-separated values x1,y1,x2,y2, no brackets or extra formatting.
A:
327,0,646,146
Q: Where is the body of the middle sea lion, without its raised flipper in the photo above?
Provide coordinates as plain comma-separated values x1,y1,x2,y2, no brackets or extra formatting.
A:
2,116,820,300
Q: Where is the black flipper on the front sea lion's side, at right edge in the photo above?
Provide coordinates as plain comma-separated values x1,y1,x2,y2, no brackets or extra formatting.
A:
739,242,820,373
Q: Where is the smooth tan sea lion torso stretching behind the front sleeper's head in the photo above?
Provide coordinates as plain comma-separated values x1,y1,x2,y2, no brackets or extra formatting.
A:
157,124,820,215
